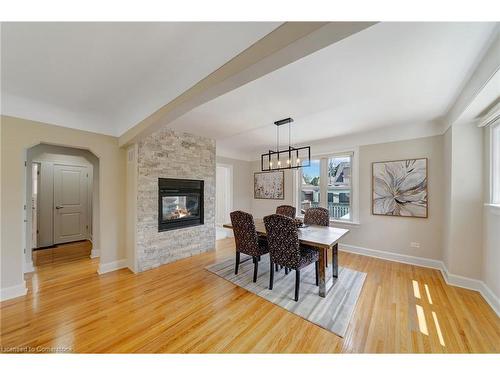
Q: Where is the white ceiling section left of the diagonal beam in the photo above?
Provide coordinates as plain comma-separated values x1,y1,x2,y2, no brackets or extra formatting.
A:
1,22,280,136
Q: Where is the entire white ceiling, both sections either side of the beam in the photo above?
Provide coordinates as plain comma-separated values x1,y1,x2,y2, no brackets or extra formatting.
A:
1,22,498,160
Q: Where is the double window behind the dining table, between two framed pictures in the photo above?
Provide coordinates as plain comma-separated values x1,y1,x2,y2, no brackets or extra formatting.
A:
298,153,354,221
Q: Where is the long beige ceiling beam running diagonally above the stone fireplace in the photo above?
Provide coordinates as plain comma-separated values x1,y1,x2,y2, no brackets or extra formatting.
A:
119,22,376,146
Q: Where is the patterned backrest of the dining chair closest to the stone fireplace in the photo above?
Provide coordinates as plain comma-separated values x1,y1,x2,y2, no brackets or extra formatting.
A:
229,211,260,256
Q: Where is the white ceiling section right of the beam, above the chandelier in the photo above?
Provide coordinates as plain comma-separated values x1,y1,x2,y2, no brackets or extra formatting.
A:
169,23,495,160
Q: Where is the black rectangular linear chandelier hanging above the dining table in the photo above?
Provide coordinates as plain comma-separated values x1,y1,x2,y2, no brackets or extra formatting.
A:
260,117,311,171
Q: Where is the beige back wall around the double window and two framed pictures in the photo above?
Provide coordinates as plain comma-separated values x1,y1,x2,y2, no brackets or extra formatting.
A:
244,135,444,260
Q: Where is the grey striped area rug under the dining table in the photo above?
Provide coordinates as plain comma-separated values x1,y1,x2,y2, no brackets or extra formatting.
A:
206,255,366,337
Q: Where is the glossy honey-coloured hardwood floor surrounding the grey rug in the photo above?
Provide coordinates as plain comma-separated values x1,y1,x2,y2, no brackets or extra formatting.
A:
0,239,500,353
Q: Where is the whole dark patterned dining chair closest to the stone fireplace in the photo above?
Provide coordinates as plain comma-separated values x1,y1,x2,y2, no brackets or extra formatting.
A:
230,211,269,283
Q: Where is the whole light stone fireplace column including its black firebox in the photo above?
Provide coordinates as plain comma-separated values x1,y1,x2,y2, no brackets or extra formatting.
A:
135,128,215,272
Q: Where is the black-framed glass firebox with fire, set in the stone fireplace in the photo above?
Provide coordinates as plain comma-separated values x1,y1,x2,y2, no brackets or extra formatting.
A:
158,178,203,232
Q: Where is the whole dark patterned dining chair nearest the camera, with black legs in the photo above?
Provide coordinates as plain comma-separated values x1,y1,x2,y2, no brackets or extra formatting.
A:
264,214,319,301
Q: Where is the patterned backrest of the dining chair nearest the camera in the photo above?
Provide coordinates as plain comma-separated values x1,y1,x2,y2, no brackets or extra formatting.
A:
264,214,300,268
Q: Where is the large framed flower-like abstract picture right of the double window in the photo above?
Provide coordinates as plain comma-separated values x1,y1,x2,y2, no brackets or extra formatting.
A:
372,158,428,218
